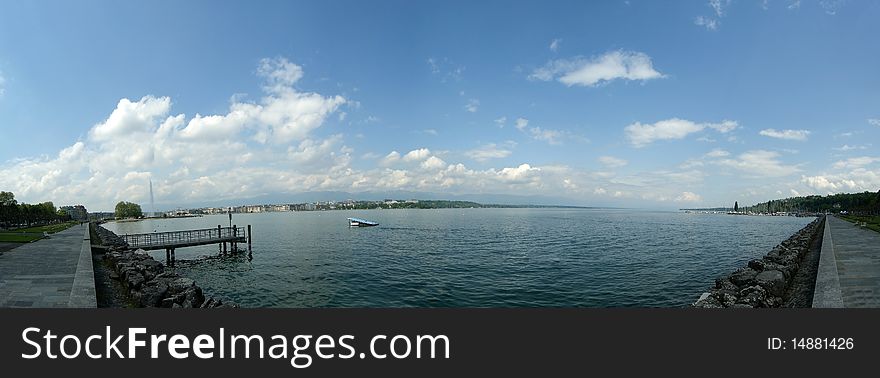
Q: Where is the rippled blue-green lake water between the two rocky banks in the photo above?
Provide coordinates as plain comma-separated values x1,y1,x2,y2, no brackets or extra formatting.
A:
104,209,814,307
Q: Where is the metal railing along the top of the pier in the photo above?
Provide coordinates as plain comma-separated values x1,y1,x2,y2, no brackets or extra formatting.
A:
122,227,247,248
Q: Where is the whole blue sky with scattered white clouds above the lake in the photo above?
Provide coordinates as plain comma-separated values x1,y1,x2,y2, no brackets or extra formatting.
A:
0,0,880,210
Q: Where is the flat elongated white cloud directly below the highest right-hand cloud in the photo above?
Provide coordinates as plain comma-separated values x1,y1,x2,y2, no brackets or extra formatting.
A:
624,118,739,148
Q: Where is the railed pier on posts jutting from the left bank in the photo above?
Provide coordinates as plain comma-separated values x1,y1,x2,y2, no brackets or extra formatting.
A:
121,225,252,265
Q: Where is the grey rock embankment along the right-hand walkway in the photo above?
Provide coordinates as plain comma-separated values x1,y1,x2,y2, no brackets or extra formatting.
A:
693,217,825,308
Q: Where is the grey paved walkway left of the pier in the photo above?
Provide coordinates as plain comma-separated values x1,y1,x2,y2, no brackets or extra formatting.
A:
0,224,96,308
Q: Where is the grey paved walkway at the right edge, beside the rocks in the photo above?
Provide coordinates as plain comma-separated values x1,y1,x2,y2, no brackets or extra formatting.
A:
813,216,880,308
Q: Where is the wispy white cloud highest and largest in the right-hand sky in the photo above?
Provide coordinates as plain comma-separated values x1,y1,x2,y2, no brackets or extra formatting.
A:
529,50,663,87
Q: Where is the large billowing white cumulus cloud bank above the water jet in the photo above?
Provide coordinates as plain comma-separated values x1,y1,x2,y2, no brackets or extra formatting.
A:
0,58,352,210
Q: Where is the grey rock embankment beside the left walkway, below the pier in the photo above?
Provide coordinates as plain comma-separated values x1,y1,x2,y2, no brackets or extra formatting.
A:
95,226,238,308
